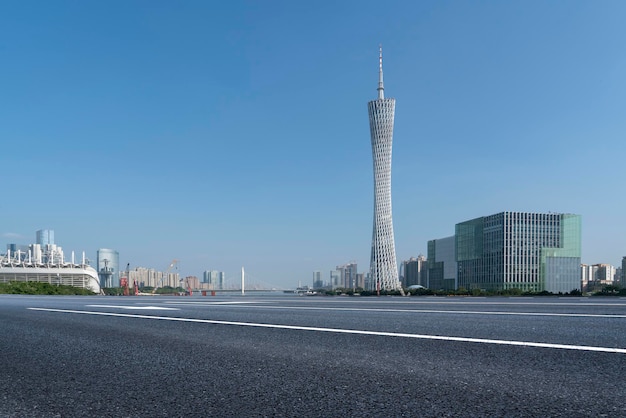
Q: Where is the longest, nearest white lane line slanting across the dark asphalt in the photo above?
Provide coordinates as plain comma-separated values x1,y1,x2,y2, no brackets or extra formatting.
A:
27,308,626,354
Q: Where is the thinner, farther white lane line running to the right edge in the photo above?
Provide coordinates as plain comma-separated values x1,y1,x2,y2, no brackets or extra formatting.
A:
165,302,626,318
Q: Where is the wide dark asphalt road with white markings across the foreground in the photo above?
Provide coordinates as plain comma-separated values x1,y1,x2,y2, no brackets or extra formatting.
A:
0,294,626,417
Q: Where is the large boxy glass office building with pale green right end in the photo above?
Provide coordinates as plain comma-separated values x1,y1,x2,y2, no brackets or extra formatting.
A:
454,212,581,293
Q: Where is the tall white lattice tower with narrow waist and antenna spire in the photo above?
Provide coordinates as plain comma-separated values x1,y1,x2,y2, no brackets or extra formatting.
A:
367,46,401,290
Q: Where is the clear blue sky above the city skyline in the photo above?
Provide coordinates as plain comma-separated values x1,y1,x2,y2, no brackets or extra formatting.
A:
0,0,626,287
